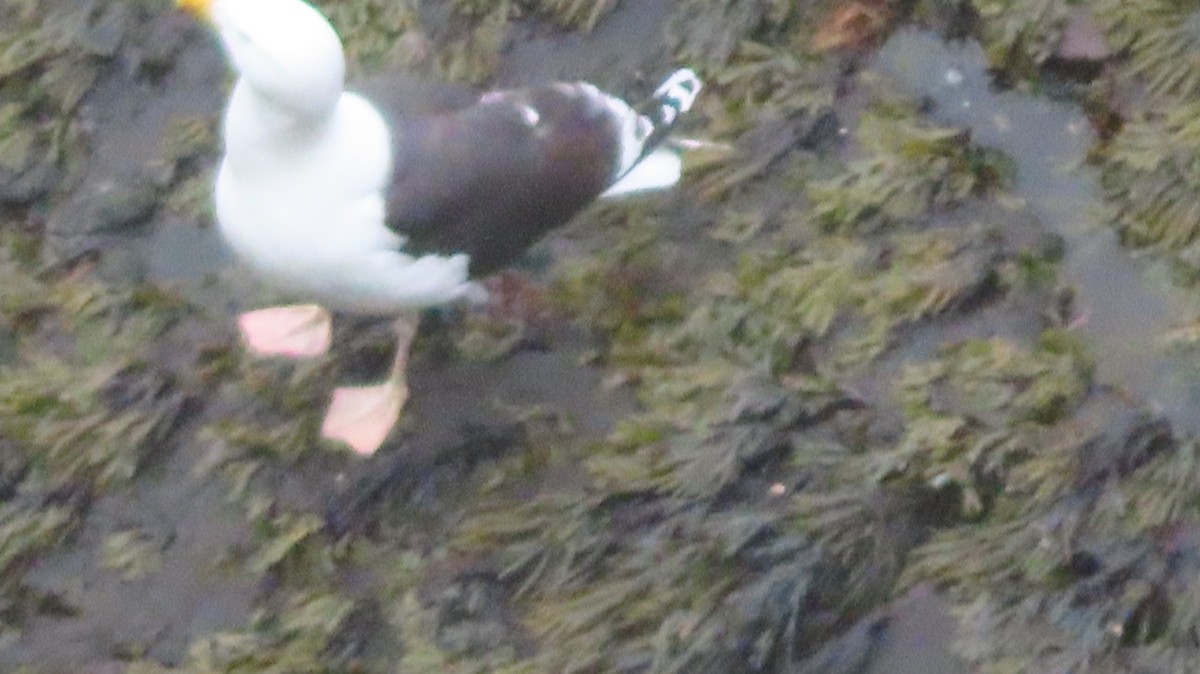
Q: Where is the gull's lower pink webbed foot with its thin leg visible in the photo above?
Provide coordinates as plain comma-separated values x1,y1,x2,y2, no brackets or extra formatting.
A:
320,314,420,455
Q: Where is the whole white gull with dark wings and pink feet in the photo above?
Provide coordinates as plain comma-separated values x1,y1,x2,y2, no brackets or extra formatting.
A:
178,0,701,453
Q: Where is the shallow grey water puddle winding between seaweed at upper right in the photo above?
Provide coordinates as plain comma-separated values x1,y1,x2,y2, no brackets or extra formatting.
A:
874,30,1200,434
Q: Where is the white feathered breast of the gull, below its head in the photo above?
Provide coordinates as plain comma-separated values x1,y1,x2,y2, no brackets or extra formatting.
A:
216,86,401,305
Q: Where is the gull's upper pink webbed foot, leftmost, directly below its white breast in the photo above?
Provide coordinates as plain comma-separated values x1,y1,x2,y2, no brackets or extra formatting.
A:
238,305,332,359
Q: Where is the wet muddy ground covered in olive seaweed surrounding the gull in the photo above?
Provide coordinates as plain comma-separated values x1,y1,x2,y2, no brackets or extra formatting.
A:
7,0,1200,674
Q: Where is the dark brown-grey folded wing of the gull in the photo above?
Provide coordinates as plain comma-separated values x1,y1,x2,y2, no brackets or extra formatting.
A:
376,85,620,276
